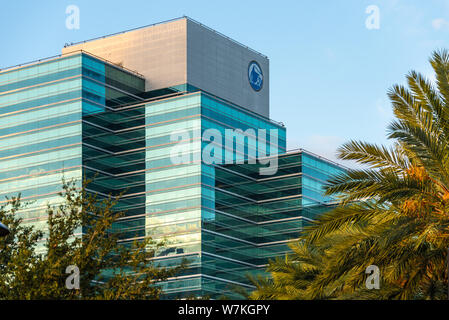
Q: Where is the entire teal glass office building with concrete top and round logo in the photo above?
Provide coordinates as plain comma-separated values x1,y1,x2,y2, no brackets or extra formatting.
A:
0,17,343,298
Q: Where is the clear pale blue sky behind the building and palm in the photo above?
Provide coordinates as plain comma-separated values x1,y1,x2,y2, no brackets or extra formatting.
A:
0,0,449,165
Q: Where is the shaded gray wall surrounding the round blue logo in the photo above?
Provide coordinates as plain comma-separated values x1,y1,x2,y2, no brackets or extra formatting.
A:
187,20,270,117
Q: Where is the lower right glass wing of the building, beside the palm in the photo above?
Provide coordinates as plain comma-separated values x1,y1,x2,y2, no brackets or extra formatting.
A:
203,151,344,298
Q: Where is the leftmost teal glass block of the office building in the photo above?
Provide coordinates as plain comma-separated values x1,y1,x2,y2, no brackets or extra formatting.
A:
0,53,145,252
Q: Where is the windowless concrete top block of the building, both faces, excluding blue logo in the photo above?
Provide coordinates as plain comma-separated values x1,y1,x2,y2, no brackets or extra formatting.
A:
62,18,269,117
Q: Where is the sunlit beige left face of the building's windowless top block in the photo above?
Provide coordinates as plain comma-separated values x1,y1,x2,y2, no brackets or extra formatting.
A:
62,19,187,91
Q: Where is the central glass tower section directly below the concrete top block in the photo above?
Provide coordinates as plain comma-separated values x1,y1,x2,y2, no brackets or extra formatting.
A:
145,92,285,297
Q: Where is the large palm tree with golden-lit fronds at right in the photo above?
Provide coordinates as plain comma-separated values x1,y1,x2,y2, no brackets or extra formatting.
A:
252,50,449,299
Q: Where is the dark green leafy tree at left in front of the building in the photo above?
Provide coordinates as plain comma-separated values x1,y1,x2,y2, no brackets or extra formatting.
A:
0,182,186,299
